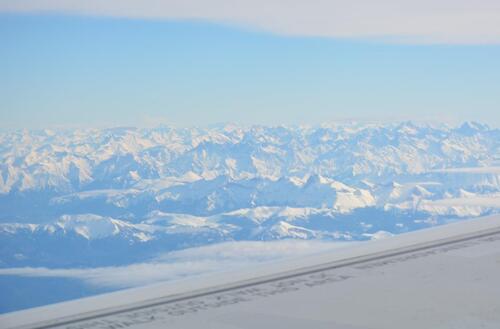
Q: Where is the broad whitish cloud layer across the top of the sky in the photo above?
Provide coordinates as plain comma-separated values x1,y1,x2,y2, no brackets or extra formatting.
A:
0,0,500,44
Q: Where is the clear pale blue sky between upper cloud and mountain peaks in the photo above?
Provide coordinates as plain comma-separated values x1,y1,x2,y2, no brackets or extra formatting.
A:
0,13,500,128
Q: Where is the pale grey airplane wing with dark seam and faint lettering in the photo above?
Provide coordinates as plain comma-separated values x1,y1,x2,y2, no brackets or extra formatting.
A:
0,216,500,329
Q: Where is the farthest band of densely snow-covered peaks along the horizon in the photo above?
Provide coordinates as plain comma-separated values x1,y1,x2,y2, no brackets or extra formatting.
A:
0,122,500,193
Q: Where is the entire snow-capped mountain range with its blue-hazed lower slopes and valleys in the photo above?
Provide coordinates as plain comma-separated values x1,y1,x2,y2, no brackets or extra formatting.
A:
0,122,500,267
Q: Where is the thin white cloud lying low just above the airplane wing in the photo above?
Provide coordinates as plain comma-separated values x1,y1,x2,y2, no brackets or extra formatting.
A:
0,240,352,288
